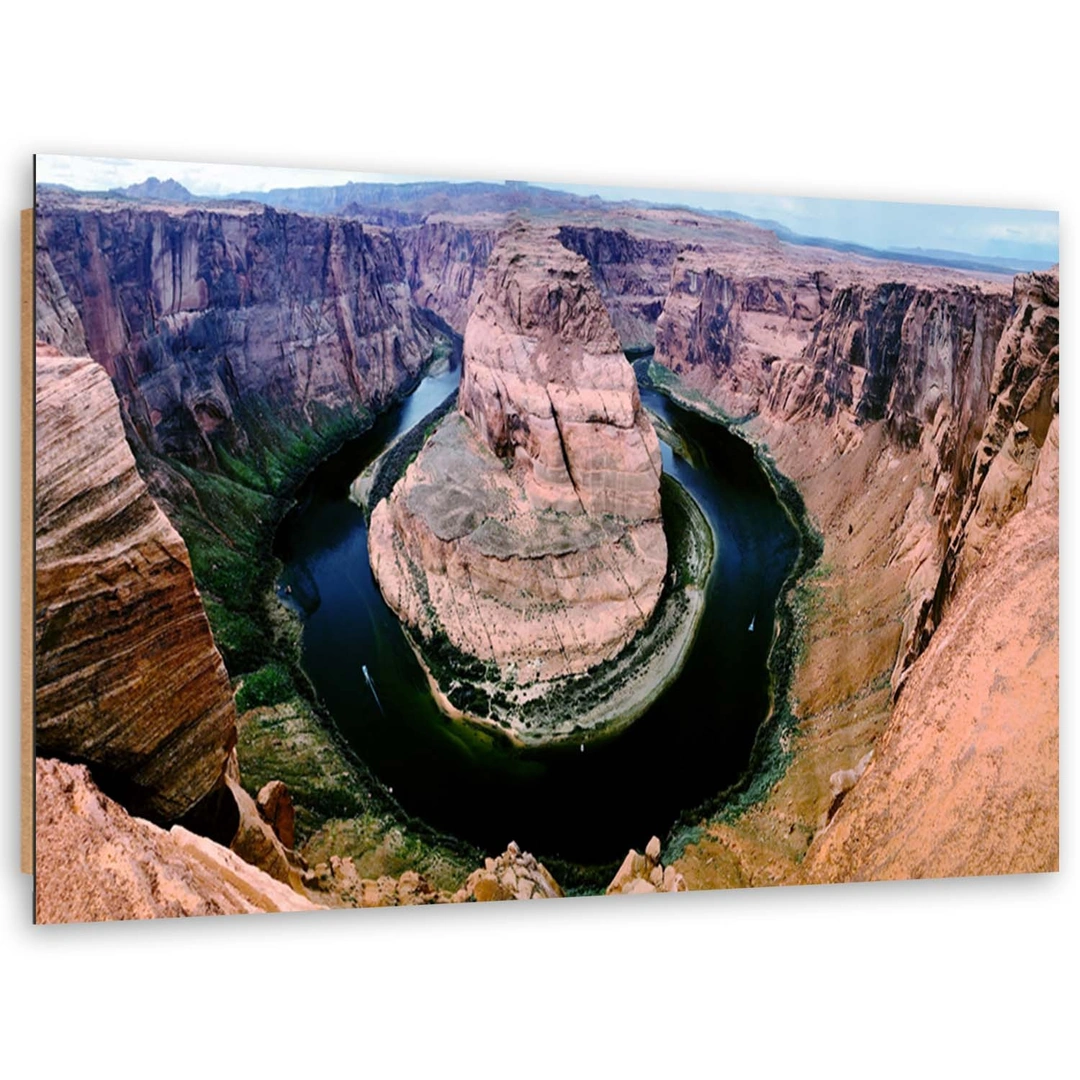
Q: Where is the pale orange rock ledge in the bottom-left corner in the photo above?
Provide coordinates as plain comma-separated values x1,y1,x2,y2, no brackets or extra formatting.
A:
35,758,318,922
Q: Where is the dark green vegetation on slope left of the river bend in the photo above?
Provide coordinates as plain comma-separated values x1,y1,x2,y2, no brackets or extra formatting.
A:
139,341,483,889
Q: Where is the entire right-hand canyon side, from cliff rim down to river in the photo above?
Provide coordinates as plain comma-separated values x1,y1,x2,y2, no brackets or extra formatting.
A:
657,266,1059,888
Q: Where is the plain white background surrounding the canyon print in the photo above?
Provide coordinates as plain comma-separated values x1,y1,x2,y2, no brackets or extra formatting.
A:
0,0,1078,1077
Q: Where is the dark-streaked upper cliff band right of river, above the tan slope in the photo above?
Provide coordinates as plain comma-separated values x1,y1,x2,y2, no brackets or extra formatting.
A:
656,251,1028,688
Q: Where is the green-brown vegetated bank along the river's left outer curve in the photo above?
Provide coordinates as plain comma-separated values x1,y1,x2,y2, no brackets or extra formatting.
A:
152,350,482,891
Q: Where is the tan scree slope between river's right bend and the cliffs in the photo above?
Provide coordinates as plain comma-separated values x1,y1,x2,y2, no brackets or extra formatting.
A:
643,362,919,889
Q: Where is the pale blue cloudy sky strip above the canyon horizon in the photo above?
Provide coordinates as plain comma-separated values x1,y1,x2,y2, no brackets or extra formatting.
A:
37,154,1058,262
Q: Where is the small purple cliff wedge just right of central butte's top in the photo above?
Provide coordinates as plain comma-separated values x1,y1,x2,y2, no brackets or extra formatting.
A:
558,225,681,352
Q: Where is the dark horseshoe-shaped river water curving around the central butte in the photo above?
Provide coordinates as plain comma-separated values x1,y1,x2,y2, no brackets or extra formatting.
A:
276,360,798,865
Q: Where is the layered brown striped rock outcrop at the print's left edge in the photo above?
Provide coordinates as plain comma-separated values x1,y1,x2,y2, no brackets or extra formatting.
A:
35,347,237,824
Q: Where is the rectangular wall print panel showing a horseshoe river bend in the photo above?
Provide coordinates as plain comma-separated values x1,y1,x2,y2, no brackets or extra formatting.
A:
25,157,1059,922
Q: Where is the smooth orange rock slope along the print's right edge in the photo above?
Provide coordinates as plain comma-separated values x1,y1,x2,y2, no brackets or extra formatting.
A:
800,285,1059,882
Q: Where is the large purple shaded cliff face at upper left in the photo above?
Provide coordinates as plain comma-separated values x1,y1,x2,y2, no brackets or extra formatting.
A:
37,200,435,468
